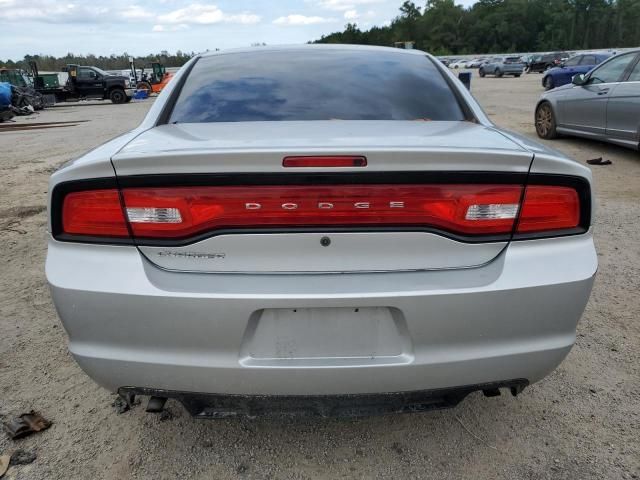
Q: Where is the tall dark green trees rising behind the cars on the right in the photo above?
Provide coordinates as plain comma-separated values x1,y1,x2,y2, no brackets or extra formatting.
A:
315,0,640,55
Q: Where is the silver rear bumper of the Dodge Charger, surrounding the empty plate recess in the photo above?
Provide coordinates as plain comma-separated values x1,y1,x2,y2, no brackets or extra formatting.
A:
46,234,597,396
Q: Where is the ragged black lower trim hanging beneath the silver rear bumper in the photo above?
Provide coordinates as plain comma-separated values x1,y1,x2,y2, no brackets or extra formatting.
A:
118,378,529,419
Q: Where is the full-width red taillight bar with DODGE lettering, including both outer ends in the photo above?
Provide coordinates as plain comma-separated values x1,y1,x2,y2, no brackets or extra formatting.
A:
53,178,589,244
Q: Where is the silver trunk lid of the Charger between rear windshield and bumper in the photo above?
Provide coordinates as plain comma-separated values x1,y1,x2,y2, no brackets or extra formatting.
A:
113,121,532,273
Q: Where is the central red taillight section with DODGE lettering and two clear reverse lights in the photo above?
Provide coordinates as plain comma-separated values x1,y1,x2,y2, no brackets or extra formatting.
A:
123,185,522,238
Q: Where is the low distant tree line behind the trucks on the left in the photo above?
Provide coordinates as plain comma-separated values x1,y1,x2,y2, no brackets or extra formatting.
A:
0,50,195,72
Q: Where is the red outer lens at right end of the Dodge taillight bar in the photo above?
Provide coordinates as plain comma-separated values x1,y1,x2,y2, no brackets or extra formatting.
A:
518,185,580,233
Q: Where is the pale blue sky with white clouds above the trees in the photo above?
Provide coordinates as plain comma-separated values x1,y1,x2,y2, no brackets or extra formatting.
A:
0,0,475,60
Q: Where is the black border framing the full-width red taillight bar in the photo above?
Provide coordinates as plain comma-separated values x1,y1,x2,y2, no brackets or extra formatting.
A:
52,171,591,247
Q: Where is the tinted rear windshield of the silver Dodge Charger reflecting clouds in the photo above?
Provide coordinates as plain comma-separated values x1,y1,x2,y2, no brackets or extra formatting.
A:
169,49,464,123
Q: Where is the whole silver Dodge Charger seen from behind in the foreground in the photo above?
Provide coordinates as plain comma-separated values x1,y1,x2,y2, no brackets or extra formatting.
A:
46,46,597,418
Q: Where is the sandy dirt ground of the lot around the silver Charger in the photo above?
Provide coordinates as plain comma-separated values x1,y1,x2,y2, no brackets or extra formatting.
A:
0,74,640,479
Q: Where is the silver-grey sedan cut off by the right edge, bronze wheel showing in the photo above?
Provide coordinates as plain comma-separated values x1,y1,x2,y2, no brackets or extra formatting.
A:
535,50,640,150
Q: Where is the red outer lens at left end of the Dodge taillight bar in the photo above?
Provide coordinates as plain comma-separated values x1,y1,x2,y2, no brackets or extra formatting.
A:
62,189,129,238
